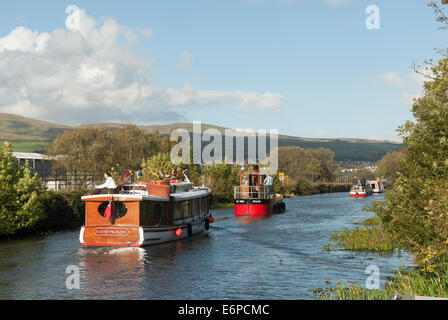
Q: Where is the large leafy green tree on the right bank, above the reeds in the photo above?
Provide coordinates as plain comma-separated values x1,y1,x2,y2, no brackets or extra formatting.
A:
373,52,448,268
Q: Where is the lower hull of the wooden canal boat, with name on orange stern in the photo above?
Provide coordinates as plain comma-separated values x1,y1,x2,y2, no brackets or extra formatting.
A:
79,217,210,247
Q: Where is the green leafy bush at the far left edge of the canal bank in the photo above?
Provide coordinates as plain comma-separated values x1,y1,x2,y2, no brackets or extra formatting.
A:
0,142,45,237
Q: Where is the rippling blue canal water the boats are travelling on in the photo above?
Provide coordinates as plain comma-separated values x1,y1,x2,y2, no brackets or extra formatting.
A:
0,193,411,299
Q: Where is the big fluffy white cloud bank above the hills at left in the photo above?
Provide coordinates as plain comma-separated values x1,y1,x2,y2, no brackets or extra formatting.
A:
0,10,285,123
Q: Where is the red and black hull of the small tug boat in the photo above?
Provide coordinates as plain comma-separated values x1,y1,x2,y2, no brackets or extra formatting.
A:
234,199,285,218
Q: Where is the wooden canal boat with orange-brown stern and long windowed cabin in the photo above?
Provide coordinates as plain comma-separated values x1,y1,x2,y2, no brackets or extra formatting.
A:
79,180,213,247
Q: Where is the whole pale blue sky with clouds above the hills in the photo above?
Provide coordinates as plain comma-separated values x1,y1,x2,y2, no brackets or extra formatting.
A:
0,0,447,141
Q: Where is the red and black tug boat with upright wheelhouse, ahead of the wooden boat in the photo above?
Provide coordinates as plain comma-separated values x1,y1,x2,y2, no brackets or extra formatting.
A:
234,166,286,218
